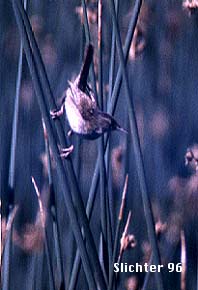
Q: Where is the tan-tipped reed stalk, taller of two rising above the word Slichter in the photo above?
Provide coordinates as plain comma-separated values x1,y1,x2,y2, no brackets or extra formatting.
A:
108,174,128,290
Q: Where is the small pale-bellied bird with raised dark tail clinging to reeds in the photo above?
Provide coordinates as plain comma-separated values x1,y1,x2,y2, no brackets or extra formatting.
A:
51,44,126,154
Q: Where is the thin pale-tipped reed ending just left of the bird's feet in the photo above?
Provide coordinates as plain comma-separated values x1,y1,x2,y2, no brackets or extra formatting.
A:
42,119,65,289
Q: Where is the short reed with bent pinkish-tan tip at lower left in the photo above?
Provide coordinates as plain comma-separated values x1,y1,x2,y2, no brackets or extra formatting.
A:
32,177,56,290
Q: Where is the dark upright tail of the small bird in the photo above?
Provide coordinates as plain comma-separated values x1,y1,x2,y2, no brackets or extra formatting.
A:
78,44,94,92
